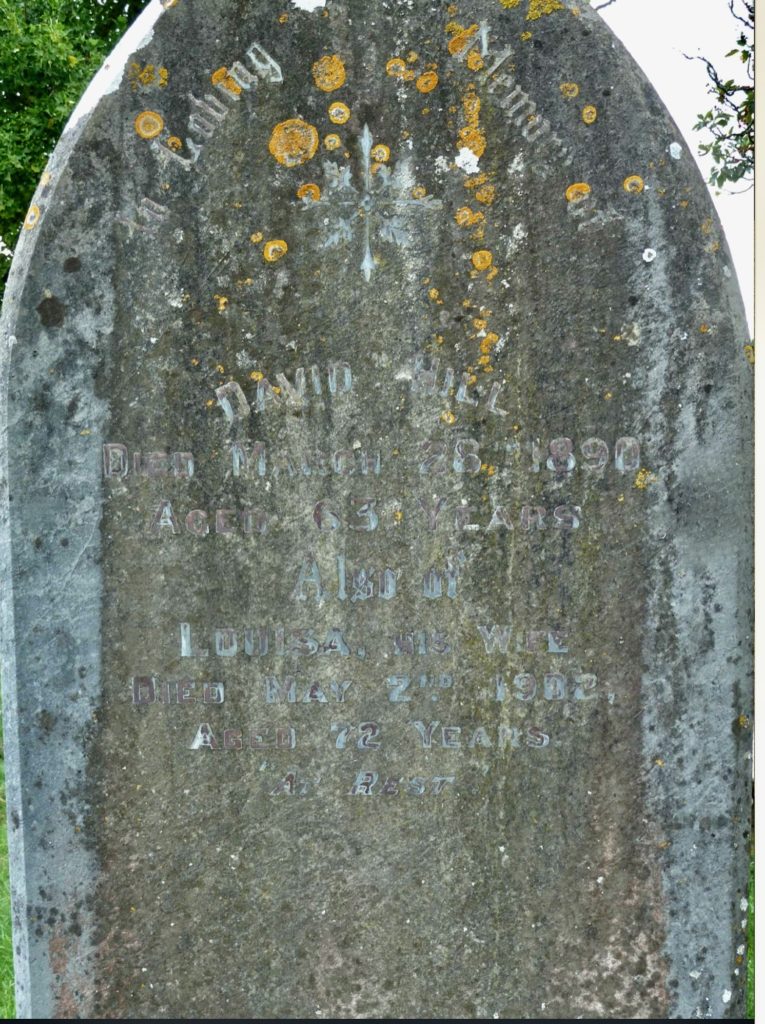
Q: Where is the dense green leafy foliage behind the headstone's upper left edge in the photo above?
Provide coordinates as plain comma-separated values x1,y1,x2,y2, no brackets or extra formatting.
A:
0,0,146,276
